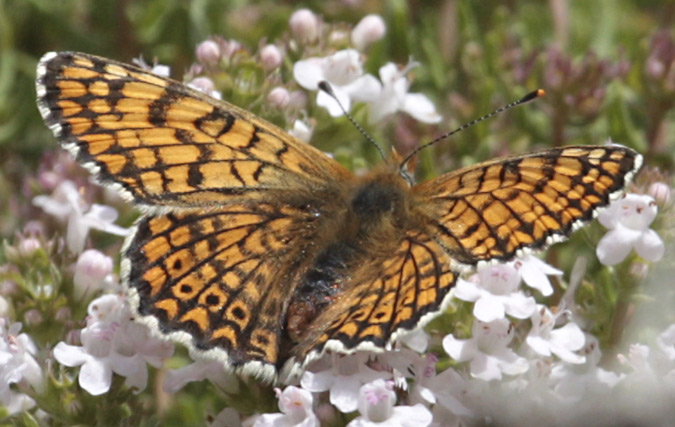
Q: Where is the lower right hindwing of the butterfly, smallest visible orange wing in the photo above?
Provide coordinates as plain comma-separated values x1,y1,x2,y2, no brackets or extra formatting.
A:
294,230,457,370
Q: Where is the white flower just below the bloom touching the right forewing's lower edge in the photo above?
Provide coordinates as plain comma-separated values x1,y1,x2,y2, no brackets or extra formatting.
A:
443,319,529,381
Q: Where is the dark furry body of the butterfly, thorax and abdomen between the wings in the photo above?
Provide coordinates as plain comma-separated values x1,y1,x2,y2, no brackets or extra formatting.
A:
286,165,412,342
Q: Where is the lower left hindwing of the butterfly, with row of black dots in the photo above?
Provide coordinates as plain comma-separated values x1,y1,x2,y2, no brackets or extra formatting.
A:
122,203,328,378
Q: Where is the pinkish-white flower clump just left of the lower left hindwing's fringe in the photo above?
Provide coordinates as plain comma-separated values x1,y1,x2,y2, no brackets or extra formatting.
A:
54,295,173,395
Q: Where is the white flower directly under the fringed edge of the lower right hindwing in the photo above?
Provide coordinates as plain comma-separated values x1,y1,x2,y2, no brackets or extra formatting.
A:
300,352,391,413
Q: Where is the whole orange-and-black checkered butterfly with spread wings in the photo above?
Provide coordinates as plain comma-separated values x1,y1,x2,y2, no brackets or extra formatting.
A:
36,52,642,379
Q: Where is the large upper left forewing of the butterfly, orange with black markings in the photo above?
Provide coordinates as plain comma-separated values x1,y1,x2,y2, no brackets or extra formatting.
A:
36,52,351,210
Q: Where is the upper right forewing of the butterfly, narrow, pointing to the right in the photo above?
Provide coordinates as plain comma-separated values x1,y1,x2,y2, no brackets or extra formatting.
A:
412,146,642,265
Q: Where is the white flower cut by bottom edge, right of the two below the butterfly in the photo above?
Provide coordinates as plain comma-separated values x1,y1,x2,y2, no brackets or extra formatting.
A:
347,379,432,427
